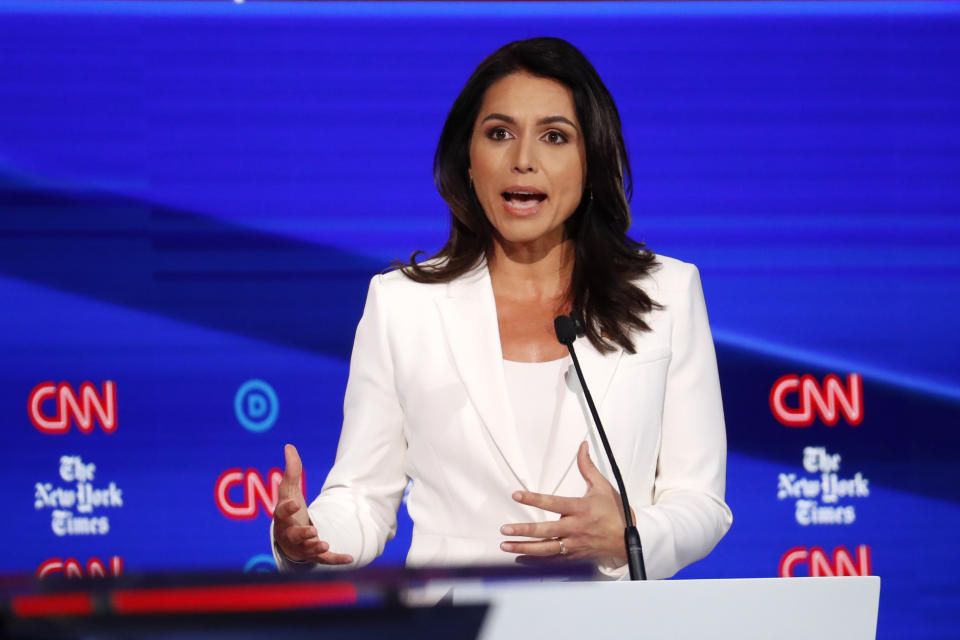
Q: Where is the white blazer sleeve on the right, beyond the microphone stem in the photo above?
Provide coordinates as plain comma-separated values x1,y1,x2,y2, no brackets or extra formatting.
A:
604,265,733,579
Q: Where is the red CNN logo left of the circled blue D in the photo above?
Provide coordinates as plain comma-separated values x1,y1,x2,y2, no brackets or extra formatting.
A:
27,380,117,434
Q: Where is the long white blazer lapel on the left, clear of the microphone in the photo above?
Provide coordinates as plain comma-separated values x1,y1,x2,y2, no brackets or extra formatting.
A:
437,262,533,491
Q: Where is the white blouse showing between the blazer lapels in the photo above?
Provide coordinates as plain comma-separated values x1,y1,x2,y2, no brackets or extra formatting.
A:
503,356,570,491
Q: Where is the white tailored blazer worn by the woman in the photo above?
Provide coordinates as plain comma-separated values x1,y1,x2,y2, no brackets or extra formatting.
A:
271,256,732,578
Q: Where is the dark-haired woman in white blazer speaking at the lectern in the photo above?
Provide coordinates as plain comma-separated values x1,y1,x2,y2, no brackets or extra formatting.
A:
272,38,731,578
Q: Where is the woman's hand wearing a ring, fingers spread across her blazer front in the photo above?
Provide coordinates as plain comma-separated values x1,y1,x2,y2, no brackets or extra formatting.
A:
500,442,627,567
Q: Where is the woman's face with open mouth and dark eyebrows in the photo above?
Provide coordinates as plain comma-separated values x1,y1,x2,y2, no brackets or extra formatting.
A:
470,72,587,248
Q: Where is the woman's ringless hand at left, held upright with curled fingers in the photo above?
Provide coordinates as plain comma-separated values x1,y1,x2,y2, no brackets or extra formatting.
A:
273,444,353,564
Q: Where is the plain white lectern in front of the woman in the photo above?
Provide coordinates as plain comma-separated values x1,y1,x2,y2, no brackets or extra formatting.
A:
452,576,880,640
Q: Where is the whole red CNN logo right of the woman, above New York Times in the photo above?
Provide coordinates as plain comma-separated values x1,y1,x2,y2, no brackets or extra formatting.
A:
770,373,863,427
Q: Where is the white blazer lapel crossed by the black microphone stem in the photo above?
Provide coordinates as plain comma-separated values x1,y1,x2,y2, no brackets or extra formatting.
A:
541,337,623,494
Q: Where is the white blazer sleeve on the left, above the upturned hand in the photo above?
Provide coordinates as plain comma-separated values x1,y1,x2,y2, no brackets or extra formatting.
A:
271,275,407,570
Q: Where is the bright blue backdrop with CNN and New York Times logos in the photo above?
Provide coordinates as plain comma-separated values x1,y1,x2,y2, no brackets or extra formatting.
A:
0,2,960,638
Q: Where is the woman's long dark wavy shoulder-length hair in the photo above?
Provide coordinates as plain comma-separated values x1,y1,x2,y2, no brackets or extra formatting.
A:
393,38,660,353
